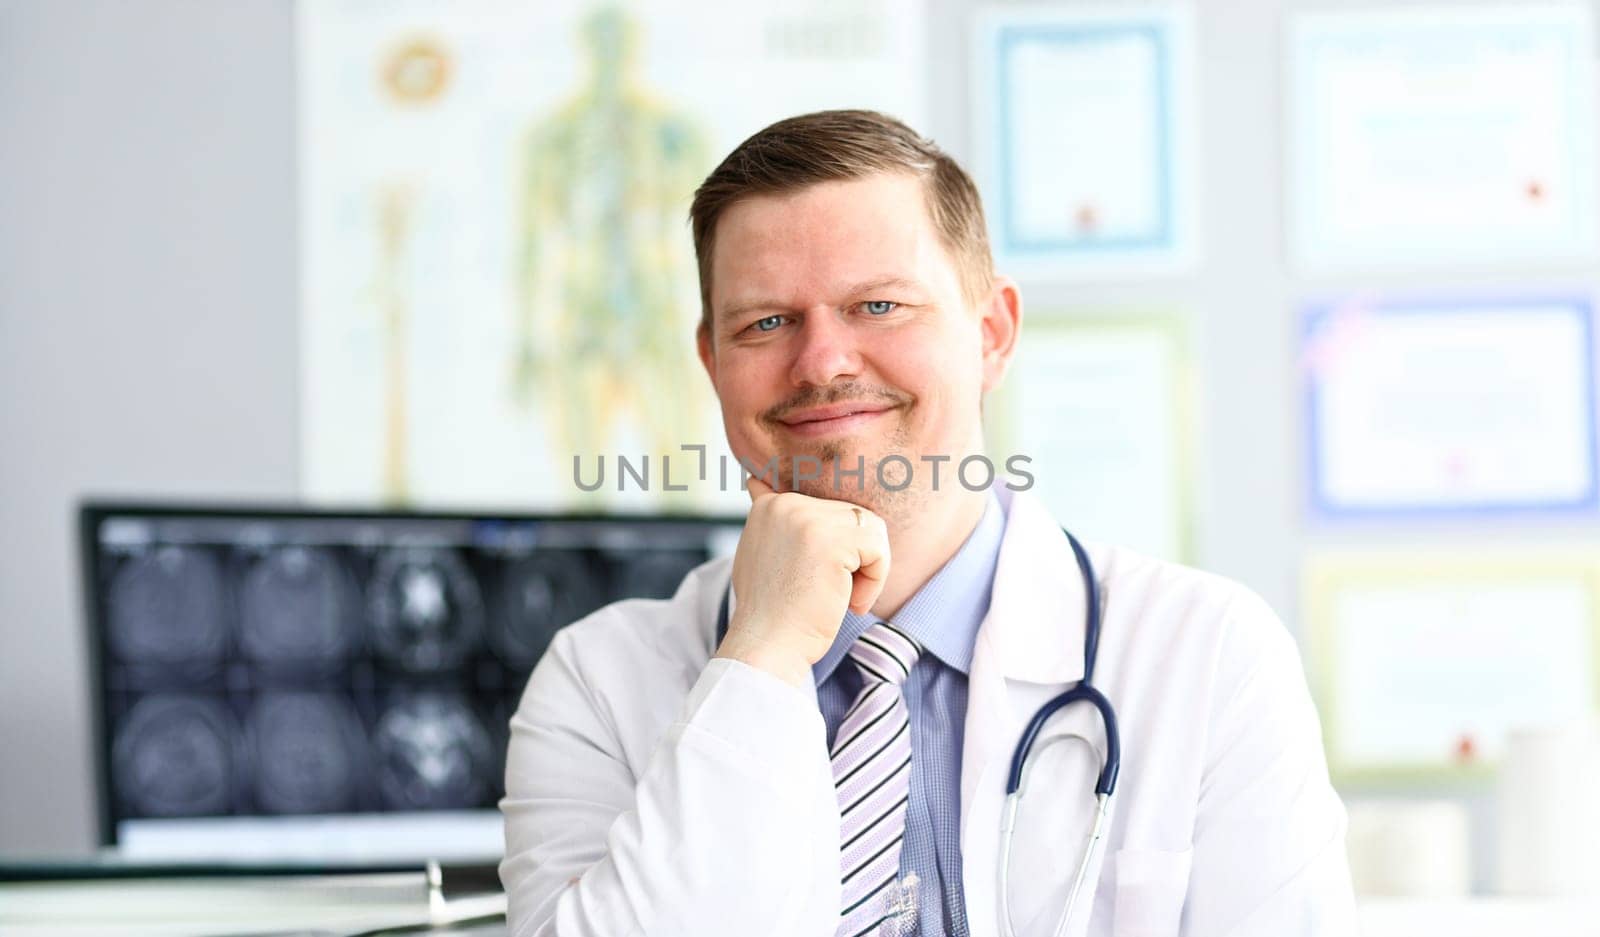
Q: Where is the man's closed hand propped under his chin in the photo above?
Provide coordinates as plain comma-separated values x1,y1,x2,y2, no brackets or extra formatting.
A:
717,478,890,686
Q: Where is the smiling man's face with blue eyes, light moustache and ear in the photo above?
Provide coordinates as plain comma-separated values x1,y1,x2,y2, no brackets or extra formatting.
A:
699,174,1018,520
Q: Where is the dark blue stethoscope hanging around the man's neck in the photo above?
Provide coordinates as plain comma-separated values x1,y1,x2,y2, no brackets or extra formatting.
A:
717,531,1122,937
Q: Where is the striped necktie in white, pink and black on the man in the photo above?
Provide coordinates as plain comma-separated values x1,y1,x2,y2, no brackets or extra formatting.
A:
830,622,922,937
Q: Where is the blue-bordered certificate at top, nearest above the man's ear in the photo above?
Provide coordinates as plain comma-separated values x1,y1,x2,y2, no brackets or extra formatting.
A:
973,3,1195,278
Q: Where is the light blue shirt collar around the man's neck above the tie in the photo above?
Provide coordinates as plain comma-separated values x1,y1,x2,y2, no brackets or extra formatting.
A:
811,489,1005,686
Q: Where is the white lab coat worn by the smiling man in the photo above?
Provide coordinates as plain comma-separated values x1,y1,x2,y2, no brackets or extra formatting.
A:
501,491,1357,937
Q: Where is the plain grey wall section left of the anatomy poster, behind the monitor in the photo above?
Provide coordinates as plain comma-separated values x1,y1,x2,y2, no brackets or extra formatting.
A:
0,0,299,852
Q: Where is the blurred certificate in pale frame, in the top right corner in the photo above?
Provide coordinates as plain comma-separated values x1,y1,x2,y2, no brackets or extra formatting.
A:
1285,3,1600,270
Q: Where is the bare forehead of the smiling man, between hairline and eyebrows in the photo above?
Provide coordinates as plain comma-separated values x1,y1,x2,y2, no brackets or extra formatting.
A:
710,173,954,310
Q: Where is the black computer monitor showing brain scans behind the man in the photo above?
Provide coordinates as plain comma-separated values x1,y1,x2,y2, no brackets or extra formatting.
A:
80,502,741,865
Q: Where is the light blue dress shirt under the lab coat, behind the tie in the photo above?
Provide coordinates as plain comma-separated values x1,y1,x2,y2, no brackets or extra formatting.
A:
811,491,1005,937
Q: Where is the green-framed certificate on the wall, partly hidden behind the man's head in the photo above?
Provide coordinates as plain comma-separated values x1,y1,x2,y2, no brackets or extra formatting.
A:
987,315,1194,561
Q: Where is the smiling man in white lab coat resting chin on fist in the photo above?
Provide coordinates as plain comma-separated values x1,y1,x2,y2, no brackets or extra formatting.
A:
501,110,1357,937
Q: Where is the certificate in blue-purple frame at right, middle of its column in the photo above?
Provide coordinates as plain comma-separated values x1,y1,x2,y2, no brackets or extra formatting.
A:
1304,297,1600,518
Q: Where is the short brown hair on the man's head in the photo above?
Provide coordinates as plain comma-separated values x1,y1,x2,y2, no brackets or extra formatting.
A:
690,110,994,331
